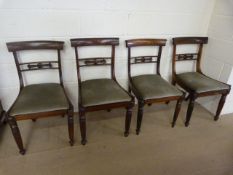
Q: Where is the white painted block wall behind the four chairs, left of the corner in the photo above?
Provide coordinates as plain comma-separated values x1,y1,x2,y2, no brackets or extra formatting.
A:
0,0,215,109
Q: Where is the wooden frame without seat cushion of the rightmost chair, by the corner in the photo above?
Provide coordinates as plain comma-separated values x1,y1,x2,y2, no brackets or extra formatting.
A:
172,37,231,127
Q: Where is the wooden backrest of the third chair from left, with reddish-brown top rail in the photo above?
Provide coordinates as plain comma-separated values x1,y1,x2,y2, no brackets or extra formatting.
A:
125,39,167,78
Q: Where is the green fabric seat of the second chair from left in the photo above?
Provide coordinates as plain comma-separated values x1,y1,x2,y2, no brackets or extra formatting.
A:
81,79,131,107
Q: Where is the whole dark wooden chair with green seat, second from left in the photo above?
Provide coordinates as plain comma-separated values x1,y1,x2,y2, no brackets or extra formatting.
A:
71,38,134,145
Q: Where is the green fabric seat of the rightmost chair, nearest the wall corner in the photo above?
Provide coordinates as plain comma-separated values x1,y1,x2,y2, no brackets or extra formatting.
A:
176,72,230,93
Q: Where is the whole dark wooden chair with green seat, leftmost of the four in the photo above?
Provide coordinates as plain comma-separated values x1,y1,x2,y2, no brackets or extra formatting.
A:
7,41,74,154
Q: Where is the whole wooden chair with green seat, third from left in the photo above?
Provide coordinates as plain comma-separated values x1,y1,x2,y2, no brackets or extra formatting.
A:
125,39,184,134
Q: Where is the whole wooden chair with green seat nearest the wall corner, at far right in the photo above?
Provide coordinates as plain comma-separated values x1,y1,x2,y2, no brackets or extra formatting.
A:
172,37,231,127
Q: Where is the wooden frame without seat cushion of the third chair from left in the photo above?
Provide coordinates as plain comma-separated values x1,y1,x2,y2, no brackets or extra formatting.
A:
125,39,184,134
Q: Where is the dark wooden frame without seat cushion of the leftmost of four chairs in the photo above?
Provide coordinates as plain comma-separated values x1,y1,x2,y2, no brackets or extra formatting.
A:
7,40,74,155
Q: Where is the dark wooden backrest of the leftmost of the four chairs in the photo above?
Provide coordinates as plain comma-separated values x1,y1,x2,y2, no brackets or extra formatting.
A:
6,41,64,89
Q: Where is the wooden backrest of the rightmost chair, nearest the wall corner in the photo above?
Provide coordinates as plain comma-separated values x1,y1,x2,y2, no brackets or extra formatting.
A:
172,37,208,76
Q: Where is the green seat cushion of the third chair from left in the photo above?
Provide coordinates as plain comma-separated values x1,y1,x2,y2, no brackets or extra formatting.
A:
132,74,182,100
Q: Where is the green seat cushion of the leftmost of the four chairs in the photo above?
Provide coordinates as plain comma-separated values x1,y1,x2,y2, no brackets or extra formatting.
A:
10,83,69,116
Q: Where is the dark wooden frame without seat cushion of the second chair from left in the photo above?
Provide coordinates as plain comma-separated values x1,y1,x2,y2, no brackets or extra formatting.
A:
70,38,134,145
